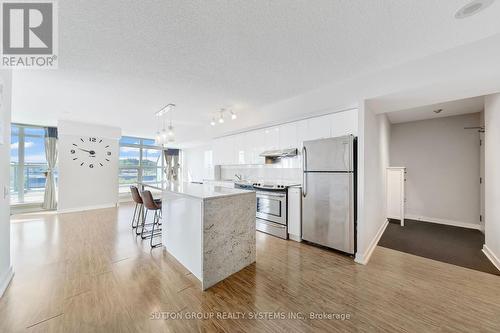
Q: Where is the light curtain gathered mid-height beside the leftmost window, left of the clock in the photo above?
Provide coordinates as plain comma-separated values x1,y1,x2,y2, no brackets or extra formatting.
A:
42,127,57,209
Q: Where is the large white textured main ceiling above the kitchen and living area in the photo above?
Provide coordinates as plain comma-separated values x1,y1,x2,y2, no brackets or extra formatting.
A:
13,0,500,141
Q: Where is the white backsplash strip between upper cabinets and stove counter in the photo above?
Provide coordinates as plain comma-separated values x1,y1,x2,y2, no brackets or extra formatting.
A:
220,164,302,183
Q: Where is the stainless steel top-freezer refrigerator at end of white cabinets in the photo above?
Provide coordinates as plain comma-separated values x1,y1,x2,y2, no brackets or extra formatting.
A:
302,135,356,254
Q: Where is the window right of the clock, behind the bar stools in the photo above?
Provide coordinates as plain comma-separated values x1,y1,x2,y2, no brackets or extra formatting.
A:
119,136,165,193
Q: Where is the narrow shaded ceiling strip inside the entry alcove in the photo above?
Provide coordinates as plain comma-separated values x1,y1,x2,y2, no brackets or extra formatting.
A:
387,96,484,124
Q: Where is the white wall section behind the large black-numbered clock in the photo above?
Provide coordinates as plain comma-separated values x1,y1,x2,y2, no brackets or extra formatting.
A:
58,121,121,212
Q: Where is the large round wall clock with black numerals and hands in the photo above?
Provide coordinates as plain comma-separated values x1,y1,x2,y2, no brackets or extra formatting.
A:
70,137,111,169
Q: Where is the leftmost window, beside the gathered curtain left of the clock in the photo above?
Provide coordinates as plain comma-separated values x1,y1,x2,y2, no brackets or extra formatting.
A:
10,124,48,205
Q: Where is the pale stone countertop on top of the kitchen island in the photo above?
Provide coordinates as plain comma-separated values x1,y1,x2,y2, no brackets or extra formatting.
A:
163,182,253,200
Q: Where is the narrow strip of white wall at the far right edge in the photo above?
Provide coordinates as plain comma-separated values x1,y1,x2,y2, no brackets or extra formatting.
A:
484,94,500,269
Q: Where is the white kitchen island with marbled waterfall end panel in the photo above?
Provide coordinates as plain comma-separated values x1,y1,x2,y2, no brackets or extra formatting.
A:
162,183,256,290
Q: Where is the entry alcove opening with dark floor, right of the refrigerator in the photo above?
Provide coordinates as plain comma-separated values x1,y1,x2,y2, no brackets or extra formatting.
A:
379,98,500,275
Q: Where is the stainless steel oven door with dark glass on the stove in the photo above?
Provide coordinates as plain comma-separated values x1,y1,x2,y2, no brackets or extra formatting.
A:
257,191,286,225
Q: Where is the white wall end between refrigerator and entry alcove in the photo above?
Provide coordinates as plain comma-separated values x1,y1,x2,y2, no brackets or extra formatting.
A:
355,105,391,264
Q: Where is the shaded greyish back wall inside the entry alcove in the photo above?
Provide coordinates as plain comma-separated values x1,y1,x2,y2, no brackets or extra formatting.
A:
390,113,480,228
